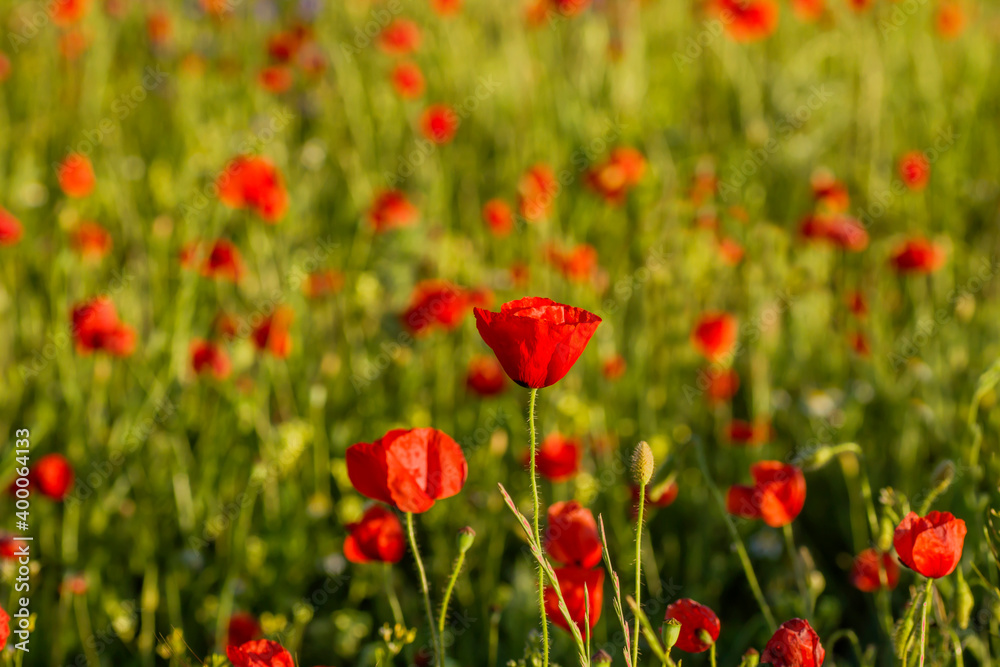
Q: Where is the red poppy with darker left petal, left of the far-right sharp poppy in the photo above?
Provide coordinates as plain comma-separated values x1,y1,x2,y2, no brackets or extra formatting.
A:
726,461,806,528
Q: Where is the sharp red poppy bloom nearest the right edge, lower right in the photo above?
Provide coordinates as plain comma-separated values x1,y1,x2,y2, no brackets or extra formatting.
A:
892,511,966,579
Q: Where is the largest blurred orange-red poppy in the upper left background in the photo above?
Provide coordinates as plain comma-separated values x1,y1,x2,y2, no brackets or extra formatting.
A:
216,155,288,223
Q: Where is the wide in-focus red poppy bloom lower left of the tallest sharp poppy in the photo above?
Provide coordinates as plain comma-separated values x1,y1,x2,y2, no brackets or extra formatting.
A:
347,428,469,512
